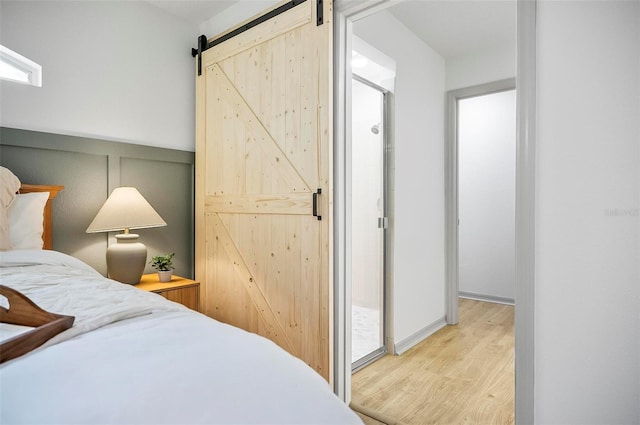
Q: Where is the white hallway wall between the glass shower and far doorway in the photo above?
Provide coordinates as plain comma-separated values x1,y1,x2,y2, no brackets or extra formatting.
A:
353,11,445,344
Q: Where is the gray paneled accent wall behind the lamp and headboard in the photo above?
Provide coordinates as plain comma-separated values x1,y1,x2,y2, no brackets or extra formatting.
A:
0,127,194,278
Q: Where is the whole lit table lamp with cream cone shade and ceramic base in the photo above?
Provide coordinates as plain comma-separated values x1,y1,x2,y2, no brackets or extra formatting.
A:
87,187,167,285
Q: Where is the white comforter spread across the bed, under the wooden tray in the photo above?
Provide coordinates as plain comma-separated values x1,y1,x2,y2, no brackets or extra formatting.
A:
0,251,361,424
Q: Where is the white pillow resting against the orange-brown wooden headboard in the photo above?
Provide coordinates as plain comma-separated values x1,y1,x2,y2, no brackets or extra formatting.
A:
7,192,49,249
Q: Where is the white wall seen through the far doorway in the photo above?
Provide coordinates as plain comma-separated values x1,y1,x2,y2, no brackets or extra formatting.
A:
458,90,516,301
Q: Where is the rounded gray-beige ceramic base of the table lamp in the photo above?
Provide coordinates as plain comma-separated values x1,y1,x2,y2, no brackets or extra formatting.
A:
107,233,147,285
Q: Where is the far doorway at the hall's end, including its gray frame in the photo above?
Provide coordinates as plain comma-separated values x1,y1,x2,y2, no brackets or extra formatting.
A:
445,78,516,324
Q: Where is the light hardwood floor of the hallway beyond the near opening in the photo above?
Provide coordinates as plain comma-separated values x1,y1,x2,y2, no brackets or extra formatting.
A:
351,299,514,425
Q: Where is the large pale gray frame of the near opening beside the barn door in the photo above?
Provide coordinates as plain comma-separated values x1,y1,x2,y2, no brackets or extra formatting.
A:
334,0,536,424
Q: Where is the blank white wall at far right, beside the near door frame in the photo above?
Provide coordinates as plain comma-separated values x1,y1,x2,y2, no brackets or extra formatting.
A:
535,1,640,424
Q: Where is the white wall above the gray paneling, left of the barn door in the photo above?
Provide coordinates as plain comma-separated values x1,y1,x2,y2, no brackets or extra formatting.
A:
0,0,198,151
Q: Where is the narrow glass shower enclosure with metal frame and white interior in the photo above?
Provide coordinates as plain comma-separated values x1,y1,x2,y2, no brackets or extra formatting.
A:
350,75,387,370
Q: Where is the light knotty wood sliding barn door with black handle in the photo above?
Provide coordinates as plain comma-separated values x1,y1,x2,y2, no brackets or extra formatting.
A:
196,0,332,381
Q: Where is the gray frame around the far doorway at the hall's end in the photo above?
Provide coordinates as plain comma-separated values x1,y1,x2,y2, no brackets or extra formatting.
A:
444,78,516,325
